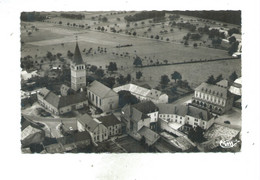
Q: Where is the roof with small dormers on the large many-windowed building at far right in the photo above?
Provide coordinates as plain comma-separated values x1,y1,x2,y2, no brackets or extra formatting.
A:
195,82,227,98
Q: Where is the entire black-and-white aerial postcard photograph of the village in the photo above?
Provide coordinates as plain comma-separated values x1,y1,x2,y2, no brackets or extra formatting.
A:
19,10,242,154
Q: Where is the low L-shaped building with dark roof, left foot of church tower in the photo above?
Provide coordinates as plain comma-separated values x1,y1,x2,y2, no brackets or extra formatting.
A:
37,88,88,115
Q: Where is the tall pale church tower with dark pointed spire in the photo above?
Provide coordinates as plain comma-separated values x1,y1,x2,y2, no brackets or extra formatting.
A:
70,42,86,91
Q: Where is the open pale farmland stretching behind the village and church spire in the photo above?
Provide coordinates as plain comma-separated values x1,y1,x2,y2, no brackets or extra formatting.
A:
21,12,241,87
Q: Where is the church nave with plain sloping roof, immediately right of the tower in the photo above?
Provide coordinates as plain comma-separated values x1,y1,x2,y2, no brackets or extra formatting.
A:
87,80,119,112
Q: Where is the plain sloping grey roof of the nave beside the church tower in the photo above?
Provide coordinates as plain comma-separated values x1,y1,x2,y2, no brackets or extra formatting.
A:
88,80,118,98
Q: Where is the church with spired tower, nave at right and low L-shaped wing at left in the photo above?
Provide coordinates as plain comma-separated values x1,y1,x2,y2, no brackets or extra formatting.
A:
37,42,119,115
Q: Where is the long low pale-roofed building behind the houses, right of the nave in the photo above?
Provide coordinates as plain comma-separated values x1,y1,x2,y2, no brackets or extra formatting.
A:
113,84,169,103
